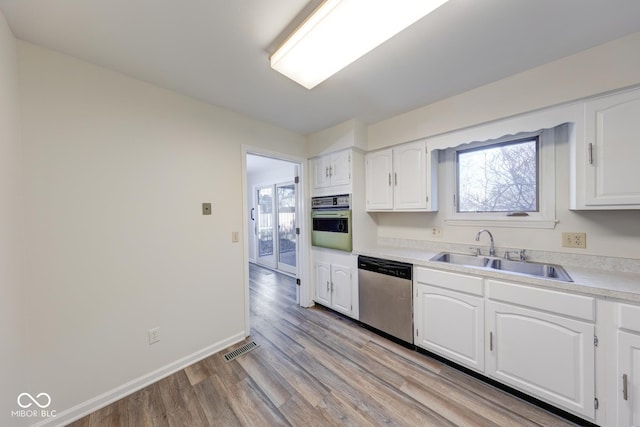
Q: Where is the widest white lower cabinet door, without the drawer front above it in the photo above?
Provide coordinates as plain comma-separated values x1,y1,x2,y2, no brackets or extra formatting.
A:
486,301,595,419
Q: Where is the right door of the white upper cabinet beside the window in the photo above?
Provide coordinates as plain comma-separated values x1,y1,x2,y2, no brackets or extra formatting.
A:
393,142,427,210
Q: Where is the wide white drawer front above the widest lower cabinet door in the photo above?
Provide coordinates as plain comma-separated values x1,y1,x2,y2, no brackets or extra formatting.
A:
487,280,596,322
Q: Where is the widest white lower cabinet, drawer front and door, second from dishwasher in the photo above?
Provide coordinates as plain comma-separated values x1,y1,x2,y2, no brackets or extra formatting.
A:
485,280,595,420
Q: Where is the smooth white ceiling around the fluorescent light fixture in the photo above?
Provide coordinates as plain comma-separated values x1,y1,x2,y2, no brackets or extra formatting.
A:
0,0,640,134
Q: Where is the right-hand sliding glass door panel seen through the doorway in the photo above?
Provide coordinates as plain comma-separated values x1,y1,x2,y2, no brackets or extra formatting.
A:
276,183,297,273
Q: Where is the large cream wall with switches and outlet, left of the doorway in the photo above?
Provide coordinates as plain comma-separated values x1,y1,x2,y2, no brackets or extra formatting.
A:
18,42,307,422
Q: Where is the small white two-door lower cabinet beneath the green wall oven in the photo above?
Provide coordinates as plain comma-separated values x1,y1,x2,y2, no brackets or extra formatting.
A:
313,250,358,318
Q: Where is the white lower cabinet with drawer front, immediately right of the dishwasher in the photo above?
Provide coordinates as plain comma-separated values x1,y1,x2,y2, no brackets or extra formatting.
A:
414,268,484,372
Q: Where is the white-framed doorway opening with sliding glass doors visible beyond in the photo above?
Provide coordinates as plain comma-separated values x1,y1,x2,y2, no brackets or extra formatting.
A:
242,146,313,342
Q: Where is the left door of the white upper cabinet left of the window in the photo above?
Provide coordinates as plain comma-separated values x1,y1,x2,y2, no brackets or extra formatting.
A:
365,149,393,211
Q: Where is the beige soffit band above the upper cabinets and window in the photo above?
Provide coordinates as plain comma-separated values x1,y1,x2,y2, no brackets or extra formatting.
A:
368,33,640,150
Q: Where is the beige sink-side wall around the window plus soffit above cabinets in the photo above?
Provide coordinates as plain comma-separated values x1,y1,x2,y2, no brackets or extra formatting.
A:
368,33,640,259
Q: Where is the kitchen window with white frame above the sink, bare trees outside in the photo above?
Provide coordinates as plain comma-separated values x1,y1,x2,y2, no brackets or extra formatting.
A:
444,124,568,228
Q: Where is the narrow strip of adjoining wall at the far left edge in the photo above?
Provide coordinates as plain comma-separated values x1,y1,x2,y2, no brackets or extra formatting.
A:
0,11,26,425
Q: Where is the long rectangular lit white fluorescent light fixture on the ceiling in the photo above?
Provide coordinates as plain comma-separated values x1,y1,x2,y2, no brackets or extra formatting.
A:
270,0,447,89
